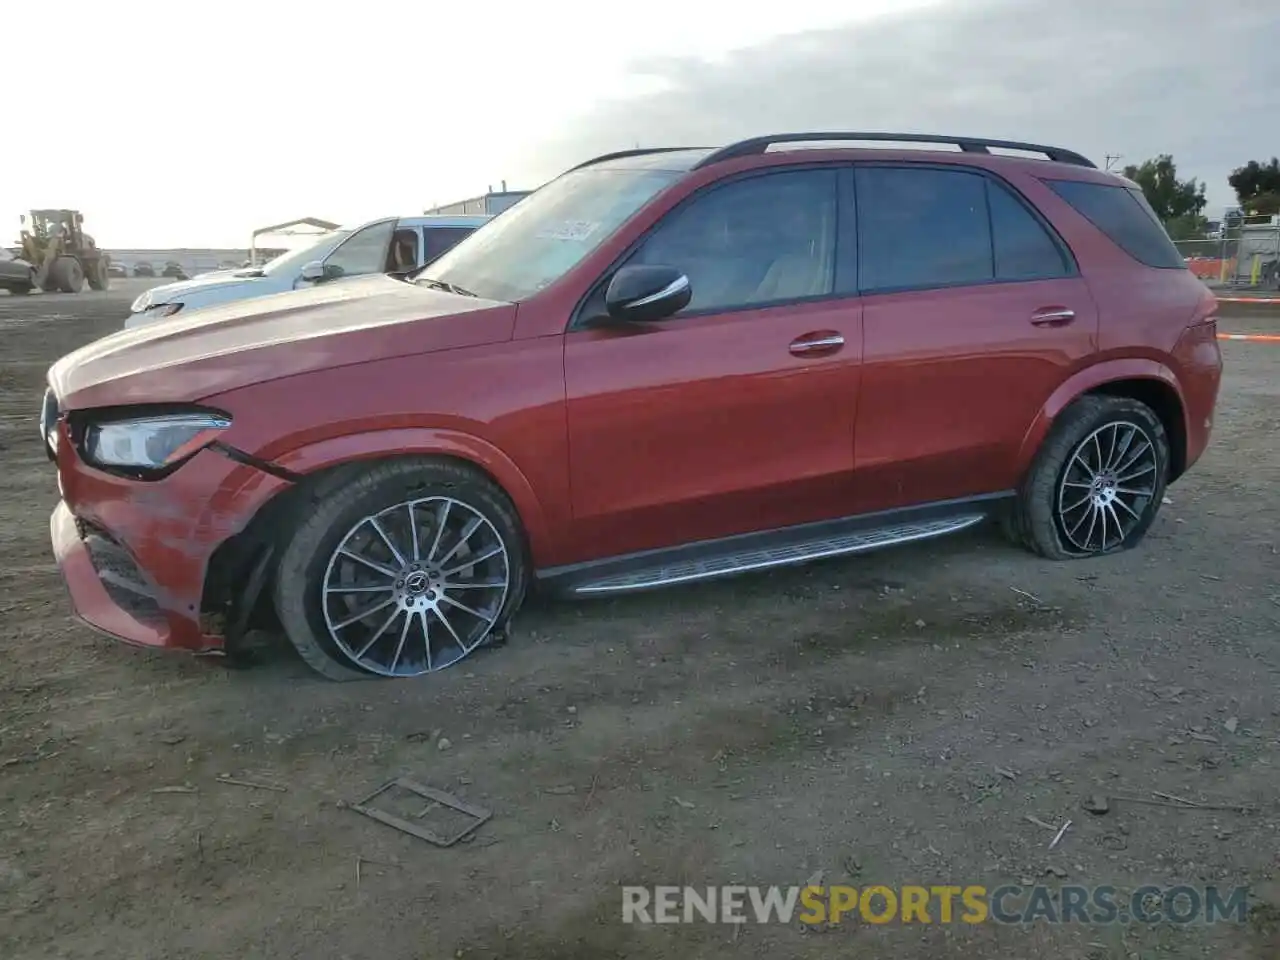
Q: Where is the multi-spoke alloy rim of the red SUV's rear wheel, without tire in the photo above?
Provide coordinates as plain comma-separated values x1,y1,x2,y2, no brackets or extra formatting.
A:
1057,420,1160,553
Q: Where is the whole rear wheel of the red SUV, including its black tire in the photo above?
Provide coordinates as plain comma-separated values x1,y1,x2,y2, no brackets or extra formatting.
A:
1000,396,1170,561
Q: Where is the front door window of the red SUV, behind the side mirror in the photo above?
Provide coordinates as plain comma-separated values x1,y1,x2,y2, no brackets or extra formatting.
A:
628,170,837,312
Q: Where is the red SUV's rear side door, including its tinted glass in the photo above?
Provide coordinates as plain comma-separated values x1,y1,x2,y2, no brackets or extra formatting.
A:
855,164,1098,511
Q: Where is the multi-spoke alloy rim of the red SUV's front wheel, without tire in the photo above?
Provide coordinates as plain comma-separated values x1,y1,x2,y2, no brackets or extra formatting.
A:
321,497,511,677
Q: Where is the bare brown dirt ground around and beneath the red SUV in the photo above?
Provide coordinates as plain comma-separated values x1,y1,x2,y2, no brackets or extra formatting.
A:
0,280,1280,960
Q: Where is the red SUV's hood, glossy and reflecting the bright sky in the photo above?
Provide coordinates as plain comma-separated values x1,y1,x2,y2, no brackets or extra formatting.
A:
49,274,516,410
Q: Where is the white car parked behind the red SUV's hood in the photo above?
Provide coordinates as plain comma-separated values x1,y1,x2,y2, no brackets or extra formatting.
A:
124,215,493,329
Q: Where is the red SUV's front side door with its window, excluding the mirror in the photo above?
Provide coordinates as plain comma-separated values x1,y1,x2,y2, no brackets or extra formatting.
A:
564,169,861,559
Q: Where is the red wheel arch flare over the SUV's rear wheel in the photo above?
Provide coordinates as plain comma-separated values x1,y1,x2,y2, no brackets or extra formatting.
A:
1018,357,1188,483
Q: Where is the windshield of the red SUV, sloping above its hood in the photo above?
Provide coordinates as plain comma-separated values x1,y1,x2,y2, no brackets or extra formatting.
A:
415,168,682,301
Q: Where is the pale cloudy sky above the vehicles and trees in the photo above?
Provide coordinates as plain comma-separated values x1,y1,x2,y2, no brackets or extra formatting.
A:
10,0,1280,248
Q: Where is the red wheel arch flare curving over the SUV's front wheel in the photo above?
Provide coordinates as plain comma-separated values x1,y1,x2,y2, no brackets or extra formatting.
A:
273,428,553,566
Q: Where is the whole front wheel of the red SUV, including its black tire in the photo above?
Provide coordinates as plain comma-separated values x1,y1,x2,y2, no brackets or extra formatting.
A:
274,458,529,681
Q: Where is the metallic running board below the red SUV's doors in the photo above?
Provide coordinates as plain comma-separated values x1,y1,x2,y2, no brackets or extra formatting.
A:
548,514,989,596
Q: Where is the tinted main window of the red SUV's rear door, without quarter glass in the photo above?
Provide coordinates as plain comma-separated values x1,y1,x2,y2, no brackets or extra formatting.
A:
856,166,995,292
